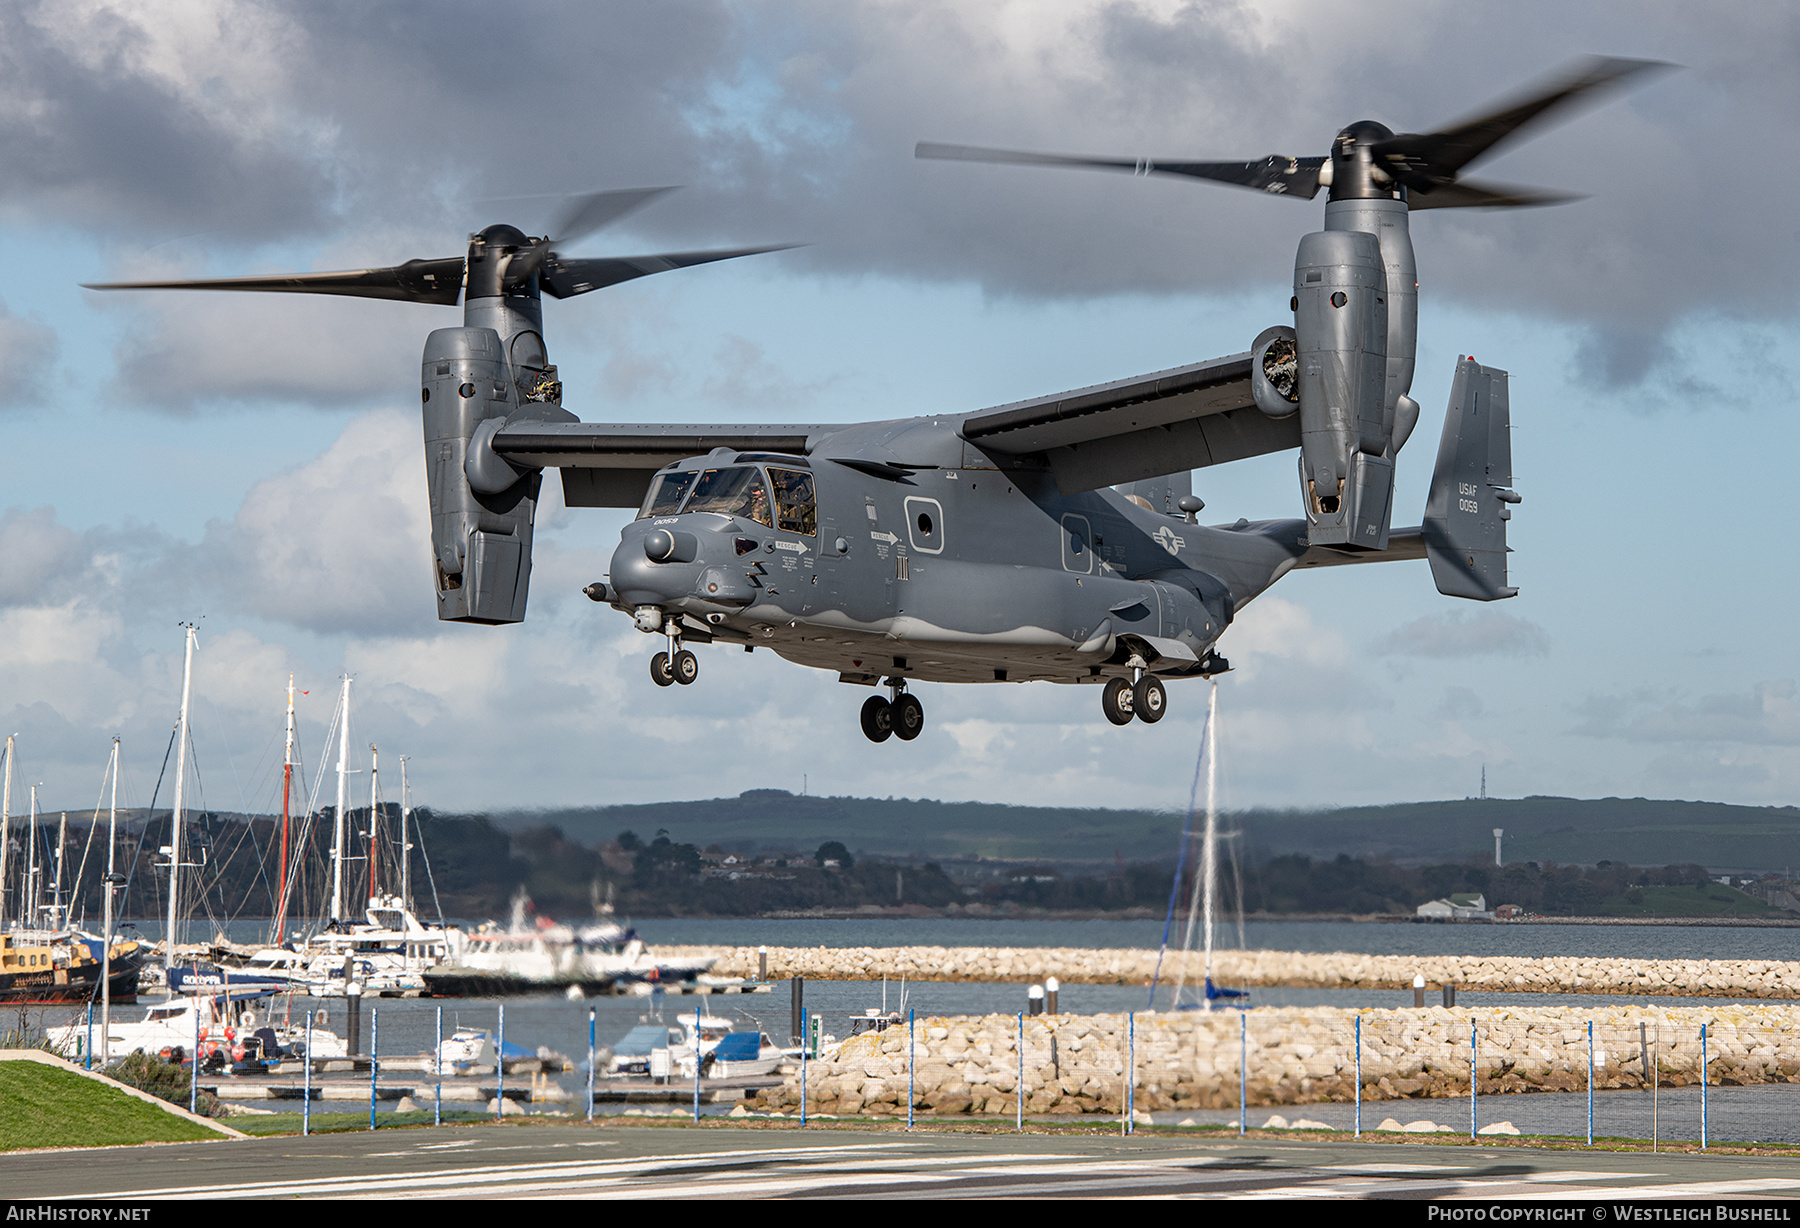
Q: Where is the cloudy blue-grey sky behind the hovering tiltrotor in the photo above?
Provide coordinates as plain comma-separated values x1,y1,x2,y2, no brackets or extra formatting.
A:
0,0,1800,831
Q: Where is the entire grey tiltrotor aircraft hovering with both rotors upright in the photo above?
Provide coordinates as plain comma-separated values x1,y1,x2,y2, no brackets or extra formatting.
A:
95,59,1652,742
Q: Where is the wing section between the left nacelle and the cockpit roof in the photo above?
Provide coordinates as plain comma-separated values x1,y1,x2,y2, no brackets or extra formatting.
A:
493,421,842,508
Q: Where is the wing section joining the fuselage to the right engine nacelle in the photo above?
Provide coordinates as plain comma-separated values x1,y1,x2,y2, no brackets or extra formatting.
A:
963,355,1300,495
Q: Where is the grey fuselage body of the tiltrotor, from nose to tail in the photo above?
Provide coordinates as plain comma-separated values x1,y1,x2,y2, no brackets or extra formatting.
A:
607,418,1307,684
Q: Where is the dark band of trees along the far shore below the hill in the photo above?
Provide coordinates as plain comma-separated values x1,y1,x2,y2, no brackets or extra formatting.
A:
7,808,1785,926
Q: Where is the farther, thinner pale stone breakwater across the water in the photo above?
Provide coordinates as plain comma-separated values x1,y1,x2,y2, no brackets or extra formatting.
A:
659,947,1800,998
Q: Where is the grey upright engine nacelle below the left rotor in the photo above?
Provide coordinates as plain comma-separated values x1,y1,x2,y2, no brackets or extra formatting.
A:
421,328,544,623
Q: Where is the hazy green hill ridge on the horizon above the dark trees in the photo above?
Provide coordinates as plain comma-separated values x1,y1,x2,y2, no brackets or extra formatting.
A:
490,789,1800,873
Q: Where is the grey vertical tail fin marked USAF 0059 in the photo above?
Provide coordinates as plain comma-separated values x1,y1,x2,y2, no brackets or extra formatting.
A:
1424,358,1519,601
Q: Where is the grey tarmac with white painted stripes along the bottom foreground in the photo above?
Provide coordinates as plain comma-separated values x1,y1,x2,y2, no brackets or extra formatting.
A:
10,1122,1800,1201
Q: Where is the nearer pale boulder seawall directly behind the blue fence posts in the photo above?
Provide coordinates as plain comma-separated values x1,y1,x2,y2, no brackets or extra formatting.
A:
754,1007,1800,1116
